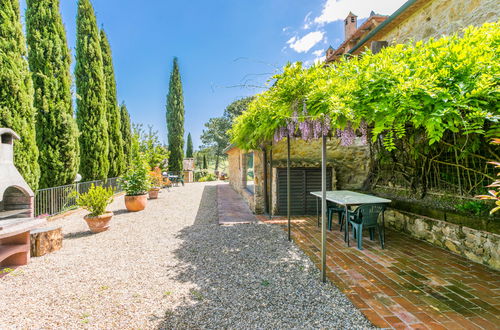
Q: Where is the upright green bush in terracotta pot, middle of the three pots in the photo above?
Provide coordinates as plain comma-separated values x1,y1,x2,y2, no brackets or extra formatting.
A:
120,162,151,212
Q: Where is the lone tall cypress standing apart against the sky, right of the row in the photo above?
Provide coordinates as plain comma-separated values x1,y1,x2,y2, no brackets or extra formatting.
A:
167,57,184,171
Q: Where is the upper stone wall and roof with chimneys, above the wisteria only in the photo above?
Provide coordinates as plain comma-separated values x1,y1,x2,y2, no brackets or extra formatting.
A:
325,0,500,63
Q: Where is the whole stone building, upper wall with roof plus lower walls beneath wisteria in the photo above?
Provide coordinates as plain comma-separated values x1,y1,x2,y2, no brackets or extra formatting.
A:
226,0,500,219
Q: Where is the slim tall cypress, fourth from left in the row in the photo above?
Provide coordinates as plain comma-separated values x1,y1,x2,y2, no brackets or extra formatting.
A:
101,29,125,178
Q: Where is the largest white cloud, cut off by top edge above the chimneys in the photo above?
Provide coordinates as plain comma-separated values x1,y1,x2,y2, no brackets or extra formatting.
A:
314,0,407,25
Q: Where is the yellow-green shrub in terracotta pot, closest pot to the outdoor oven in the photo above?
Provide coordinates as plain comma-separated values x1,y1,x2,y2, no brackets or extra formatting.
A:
76,184,115,233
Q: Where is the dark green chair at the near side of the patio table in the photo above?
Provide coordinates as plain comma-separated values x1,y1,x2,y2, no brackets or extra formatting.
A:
346,204,385,250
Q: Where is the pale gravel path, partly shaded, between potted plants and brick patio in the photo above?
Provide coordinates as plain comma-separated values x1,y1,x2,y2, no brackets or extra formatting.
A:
0,183,370,329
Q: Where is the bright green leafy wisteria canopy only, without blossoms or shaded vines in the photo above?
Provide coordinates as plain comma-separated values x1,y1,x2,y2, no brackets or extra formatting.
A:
231,23,500,150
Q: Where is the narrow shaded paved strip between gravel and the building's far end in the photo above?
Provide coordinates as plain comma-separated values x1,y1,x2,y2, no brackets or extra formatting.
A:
217,183,257,225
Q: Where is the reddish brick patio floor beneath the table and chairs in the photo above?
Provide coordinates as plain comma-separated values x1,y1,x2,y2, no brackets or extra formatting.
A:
259,216,500,329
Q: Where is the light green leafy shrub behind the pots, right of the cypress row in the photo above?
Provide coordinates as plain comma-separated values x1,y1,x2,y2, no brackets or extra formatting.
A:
134,125,169,170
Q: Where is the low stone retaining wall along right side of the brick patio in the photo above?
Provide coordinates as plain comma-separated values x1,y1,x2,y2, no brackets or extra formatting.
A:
385,209,500,270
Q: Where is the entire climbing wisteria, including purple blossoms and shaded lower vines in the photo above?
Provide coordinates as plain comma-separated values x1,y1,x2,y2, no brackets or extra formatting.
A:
231,23,500,199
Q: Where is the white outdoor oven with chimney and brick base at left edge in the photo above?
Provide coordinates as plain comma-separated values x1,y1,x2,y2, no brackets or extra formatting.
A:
0,128,45,270
